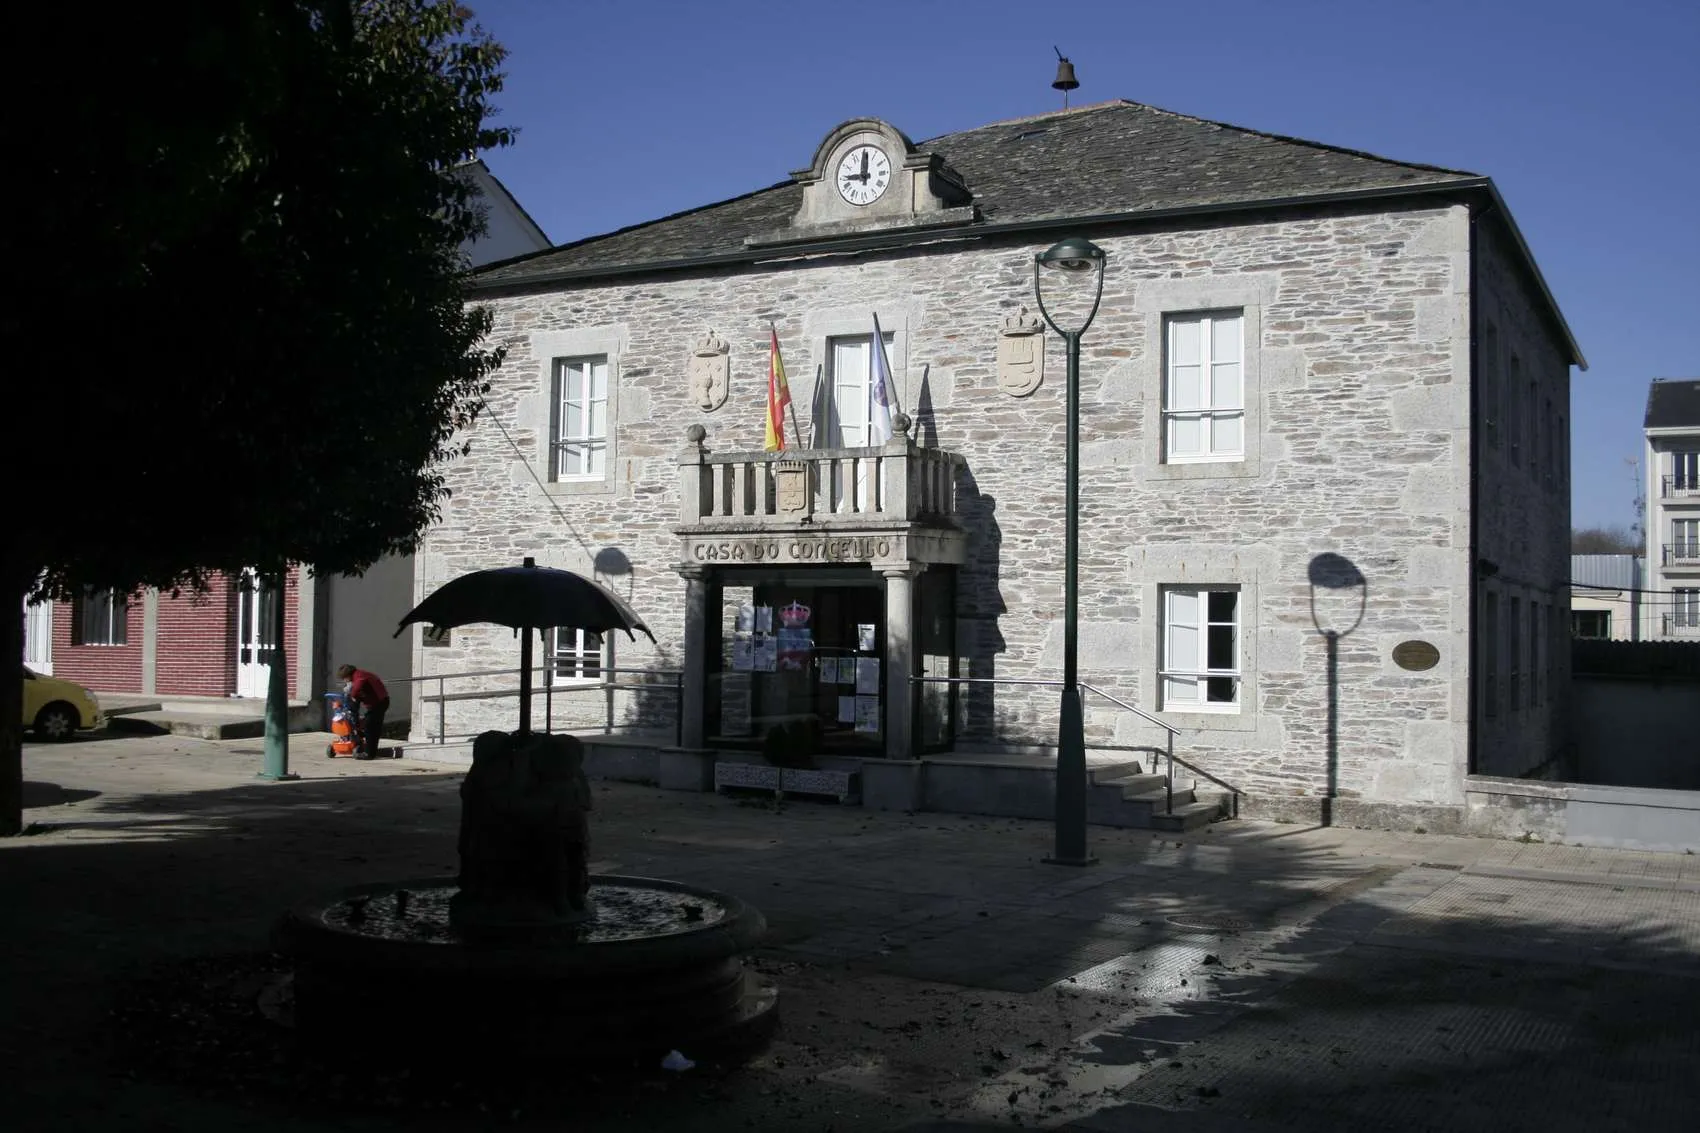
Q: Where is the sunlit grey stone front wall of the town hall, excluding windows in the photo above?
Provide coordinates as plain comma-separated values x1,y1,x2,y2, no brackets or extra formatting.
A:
428,208,1489,803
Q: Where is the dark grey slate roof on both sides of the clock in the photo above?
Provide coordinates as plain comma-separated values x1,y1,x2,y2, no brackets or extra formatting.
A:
473,102,1484,289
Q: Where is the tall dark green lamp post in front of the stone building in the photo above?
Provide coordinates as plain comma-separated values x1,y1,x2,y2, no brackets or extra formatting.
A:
1034,236,1103,866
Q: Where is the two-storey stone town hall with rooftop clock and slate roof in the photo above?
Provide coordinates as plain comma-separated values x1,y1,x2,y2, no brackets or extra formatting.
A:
413,102,1583,822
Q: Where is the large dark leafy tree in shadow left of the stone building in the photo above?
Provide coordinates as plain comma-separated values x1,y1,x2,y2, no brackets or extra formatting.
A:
0,0,512,834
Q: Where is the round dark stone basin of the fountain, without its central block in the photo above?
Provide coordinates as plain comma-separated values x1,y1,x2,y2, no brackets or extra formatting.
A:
272,874,777,1067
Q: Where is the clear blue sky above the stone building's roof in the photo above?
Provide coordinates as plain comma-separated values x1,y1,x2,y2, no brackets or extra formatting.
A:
471,0,1700,527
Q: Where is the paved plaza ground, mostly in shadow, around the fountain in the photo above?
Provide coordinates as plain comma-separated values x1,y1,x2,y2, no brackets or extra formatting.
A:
0,735,1700,1133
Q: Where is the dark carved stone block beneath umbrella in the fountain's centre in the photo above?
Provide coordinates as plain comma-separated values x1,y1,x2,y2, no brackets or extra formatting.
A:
449,732,592,936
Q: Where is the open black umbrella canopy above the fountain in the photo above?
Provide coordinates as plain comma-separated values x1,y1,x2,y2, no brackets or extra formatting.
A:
396,558,655,641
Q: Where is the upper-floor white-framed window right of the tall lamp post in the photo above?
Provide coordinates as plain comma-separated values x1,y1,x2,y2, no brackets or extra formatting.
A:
1163,311,1246,464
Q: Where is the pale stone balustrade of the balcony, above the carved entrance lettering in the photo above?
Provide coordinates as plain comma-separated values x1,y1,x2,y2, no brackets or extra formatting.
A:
678,425,964,527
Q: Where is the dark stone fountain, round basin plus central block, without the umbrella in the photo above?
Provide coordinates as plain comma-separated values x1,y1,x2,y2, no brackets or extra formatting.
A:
274,732,777,1068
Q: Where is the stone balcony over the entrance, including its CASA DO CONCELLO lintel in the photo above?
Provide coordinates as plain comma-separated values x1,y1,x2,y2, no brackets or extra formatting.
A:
677,427,967,567
